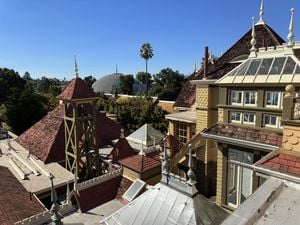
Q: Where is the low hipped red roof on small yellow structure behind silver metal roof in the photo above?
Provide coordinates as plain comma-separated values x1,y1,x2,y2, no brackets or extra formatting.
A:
119,152,161,173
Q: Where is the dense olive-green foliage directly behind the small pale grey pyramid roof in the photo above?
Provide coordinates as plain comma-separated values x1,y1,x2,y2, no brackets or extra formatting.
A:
114,98,167,132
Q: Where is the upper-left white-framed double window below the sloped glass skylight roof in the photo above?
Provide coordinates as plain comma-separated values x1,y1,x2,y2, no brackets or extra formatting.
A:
231,91,257,106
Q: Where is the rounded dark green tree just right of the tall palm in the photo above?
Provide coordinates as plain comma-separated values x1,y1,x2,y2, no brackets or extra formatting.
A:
150,68,187,101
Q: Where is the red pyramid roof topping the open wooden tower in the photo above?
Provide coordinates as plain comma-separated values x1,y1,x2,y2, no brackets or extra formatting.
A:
57,78,96,100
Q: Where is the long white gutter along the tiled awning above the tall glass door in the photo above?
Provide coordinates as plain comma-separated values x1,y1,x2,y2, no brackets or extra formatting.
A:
201,133,279,151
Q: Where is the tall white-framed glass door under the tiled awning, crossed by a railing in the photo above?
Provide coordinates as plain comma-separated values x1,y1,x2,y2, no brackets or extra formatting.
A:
227,149,254,208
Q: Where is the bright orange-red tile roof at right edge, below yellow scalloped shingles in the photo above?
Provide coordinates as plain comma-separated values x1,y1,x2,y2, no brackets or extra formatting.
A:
258,151,300,177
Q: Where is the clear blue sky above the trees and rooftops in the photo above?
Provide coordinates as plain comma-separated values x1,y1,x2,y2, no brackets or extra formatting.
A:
0,0,300,79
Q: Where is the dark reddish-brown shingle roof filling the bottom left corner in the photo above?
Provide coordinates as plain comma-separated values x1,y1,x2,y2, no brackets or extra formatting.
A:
0,166,46,225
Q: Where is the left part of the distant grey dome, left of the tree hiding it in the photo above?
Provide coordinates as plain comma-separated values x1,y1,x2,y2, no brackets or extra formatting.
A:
92,73,123,93
